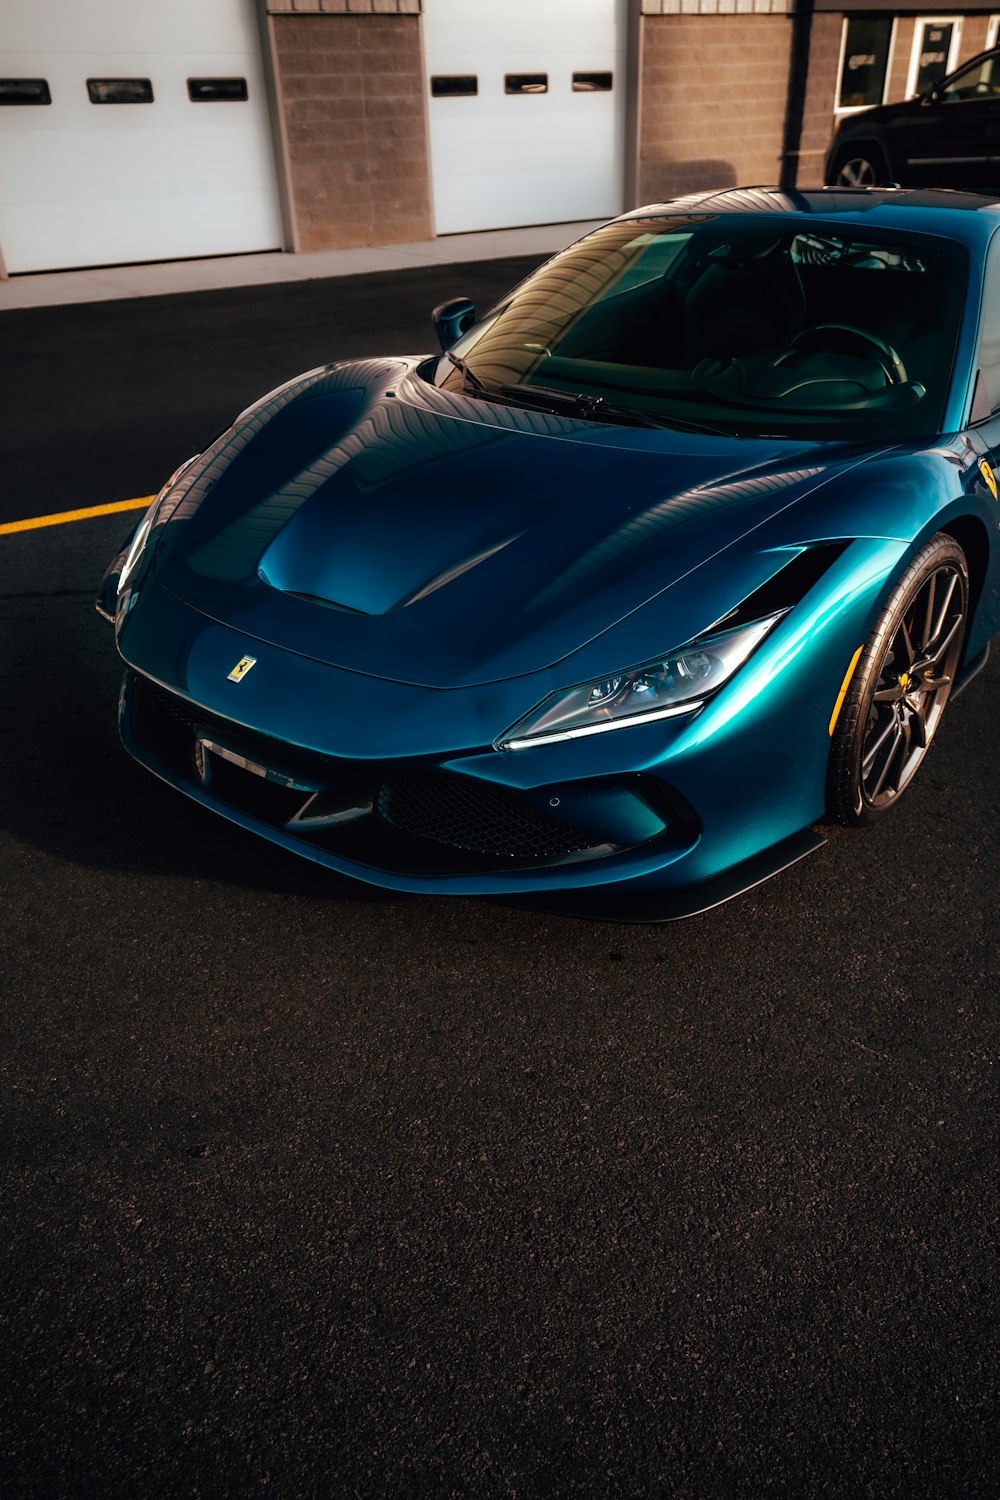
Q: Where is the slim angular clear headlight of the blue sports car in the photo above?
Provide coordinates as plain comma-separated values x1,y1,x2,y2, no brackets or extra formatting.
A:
496,609,786,750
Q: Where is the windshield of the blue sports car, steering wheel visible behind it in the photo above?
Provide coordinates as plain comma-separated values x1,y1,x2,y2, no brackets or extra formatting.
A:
435,215,966,443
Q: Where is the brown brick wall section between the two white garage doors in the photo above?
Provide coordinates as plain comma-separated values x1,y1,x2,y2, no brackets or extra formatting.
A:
270,13,432,251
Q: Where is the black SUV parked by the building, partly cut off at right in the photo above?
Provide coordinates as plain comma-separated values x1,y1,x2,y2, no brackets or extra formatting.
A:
825,47,1000,194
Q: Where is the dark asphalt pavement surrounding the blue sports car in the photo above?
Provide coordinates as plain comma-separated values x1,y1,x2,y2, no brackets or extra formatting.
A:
0,258,1000,1500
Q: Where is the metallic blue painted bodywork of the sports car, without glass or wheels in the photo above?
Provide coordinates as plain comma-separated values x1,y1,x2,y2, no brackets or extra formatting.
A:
105,192,1000,915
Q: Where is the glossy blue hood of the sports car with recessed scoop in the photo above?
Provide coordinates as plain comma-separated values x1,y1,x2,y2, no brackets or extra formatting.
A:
156,362,858,687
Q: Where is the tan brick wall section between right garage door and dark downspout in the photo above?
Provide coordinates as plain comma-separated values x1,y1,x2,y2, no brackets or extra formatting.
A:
637,14,792,203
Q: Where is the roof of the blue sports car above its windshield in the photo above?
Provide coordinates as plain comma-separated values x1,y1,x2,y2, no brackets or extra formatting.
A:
621,188,1000,252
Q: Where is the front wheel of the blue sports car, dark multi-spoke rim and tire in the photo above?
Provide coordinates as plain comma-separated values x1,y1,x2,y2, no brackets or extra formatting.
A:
828,533,969,825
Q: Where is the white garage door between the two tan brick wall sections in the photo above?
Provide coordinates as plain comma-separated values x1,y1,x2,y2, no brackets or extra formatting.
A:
423,0,625,234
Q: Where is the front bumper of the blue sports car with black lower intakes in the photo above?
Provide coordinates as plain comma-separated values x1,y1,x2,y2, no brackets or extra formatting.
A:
109,564,863,921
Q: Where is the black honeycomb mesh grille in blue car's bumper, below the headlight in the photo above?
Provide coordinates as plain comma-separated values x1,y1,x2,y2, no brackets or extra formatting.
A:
376,773,597,863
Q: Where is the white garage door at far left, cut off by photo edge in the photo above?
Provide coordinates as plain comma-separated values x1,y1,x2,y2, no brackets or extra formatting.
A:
0,0,282,272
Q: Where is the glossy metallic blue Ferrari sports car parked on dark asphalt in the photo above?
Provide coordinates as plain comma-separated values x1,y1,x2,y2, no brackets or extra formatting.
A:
99,189,1000,920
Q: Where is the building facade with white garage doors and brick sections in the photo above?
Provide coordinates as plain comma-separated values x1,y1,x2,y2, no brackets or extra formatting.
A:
0,0,1000,275
